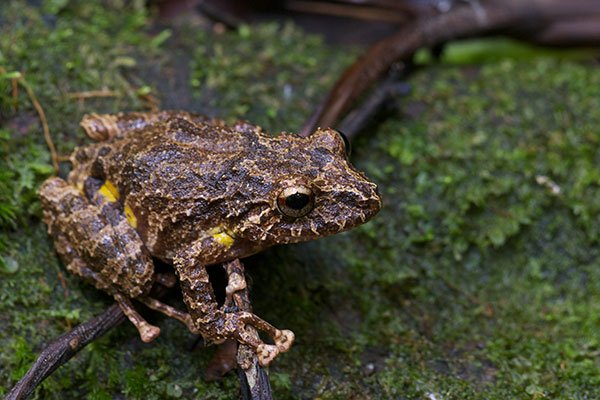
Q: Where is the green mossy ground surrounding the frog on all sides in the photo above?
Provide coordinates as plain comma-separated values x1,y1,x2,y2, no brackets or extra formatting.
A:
0,0,600,399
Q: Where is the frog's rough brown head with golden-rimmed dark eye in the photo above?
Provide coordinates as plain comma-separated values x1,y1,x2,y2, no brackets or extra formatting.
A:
232,129,381,248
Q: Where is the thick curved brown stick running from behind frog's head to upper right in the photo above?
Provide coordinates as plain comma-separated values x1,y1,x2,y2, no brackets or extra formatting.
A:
299,0,600,136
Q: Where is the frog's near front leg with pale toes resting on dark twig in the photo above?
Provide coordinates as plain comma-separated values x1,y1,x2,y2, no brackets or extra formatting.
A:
174,245,294,366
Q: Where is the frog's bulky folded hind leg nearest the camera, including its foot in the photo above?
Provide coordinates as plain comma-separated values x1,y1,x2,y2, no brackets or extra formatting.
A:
38,178,160,342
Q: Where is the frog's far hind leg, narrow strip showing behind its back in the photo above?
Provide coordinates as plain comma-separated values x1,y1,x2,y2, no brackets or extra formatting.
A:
79,111,213,142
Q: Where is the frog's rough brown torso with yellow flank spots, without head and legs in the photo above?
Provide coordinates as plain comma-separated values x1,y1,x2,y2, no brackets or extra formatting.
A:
69,117,267,261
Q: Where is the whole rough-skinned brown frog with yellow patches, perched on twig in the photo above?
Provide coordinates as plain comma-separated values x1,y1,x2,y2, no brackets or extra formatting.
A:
38,111,382,366
